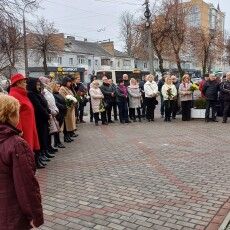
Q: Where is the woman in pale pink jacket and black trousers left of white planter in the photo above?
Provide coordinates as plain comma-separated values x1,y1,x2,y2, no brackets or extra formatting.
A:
179,74,192,121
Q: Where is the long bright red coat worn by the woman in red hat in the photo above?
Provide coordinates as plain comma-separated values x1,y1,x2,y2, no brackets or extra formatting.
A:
10,87,40,150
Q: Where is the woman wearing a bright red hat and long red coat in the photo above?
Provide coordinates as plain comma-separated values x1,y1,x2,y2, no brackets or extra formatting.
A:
9,74,40,151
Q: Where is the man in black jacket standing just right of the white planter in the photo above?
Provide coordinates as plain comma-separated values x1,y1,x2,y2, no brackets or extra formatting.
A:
203,74,220,122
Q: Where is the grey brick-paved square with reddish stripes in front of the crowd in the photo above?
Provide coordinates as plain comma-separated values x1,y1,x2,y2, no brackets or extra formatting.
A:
38,113,230,230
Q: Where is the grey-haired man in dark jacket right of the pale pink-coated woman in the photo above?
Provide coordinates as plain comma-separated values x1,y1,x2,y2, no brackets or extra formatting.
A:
101,76,115,123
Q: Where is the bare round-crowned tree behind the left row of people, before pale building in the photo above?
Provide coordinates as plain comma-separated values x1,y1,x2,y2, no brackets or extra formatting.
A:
28,18,64,75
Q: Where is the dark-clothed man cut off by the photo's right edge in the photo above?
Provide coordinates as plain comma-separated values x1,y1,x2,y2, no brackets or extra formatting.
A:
221,72,230,123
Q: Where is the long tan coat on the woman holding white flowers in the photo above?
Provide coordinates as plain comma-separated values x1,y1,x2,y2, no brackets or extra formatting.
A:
59,86,77,132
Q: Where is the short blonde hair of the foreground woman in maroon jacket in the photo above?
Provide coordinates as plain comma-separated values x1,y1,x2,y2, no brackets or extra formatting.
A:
0,93,20,123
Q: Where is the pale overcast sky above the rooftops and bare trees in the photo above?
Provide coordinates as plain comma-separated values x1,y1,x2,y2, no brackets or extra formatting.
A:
34,0,230,50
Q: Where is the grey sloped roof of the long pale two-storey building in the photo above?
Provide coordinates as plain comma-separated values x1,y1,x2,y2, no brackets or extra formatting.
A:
65,38,111,57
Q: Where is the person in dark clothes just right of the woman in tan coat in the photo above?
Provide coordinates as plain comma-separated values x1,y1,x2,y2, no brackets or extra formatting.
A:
74,76,88,123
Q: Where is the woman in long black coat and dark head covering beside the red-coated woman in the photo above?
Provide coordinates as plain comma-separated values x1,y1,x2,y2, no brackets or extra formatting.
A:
27,78,54,164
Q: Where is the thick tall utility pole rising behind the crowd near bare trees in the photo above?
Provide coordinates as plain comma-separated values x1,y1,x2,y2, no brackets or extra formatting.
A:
144,0,154,74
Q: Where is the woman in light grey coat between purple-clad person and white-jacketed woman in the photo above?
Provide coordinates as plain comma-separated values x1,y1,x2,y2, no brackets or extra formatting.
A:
128,78,141,122
